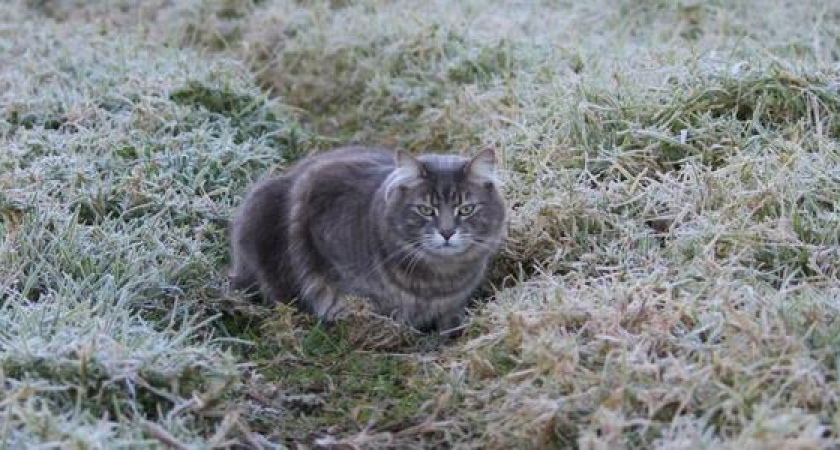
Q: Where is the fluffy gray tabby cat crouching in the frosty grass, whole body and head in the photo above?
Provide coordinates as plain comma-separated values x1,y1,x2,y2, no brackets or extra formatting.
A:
231,147,505,331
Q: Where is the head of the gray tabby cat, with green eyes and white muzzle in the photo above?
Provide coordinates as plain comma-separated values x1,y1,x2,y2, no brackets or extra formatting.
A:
382,149,505,260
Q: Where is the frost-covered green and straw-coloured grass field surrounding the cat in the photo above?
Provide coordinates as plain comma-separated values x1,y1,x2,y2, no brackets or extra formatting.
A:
0,0,840,449
